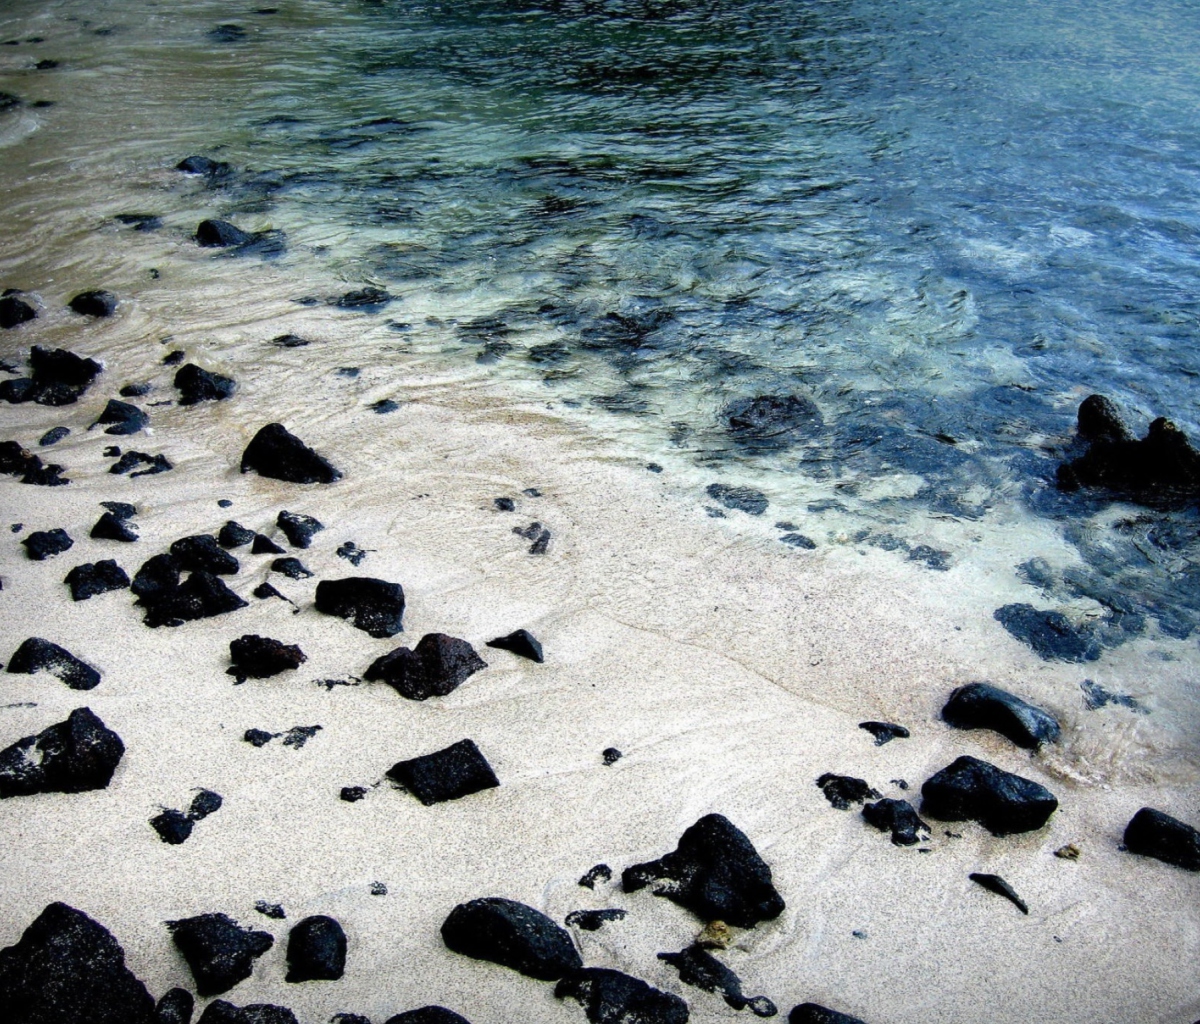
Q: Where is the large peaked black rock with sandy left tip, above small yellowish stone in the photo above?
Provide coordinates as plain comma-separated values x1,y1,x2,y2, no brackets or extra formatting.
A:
620,814,784,928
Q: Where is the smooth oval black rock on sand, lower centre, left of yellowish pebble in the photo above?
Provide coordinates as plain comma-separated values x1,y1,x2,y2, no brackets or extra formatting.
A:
442,897,583,981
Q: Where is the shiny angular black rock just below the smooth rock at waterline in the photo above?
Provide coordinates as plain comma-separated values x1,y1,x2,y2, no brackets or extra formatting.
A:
920,756,1058,836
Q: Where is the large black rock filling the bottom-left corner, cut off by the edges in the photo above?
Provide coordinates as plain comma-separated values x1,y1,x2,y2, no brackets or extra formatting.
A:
0,903,155,1024
